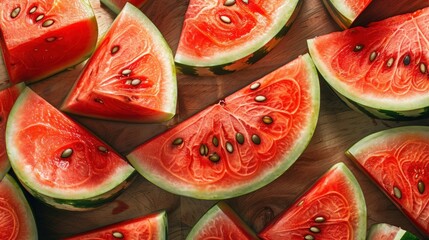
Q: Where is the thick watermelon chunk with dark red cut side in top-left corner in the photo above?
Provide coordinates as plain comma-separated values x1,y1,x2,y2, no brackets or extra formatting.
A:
0,0,98,84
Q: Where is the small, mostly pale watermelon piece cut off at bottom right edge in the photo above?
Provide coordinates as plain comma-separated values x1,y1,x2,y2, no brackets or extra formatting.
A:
366,223,419,240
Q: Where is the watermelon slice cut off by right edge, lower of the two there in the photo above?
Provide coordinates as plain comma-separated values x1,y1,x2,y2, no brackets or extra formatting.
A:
346,126,429,235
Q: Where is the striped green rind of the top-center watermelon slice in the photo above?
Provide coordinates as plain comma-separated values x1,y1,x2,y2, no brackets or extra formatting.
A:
174,0,303,76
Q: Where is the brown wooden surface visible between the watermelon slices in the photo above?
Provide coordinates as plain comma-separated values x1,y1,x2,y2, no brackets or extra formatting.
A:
0,0,429,239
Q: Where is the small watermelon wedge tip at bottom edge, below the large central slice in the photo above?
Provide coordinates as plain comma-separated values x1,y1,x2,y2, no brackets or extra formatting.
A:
186,202,259,240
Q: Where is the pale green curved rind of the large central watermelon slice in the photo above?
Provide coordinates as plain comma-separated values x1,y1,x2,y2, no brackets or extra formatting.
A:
126,54,320,200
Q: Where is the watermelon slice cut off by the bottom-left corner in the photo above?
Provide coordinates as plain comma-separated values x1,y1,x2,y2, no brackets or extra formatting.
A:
0,174,37,240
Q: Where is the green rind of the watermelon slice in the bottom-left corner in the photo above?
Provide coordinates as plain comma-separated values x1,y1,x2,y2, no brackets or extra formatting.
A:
1,174,38,240
